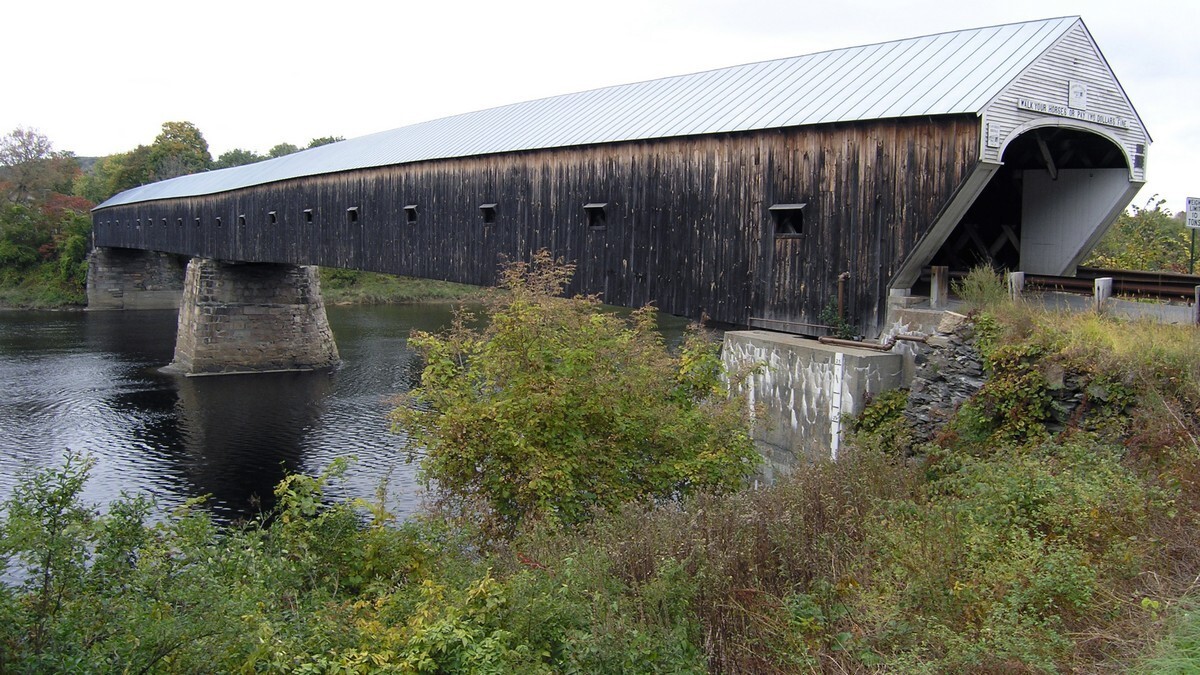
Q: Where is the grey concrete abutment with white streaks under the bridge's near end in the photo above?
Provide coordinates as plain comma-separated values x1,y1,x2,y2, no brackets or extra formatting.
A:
721,330,904,480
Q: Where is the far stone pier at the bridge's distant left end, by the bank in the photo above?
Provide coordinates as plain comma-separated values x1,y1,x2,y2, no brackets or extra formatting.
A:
88,249,186,310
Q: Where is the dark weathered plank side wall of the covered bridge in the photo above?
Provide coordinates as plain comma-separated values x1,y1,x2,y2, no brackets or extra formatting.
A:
94,117,979,335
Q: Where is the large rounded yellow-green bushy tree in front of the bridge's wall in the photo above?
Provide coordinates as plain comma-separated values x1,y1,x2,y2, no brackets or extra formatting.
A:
394,251,757,531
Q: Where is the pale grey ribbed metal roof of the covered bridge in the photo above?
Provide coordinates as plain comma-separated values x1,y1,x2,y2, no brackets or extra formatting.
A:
97,17,1080,208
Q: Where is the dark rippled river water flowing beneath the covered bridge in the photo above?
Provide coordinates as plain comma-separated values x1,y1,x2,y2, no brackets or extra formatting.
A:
0,304,683,520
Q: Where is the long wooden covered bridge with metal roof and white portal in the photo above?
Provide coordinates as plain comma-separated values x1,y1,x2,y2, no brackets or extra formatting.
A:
90,17,1150,372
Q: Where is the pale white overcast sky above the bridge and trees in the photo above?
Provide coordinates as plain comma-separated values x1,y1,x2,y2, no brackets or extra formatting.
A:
0,0,1200,211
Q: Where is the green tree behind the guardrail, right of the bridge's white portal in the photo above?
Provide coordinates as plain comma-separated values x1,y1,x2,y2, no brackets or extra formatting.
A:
1084,195,1190,273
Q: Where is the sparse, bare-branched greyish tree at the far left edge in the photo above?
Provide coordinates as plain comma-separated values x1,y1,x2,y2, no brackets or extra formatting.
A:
0,126,79,201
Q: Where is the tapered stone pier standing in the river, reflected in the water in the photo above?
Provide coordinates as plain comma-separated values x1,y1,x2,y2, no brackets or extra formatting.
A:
164,258,338,375
